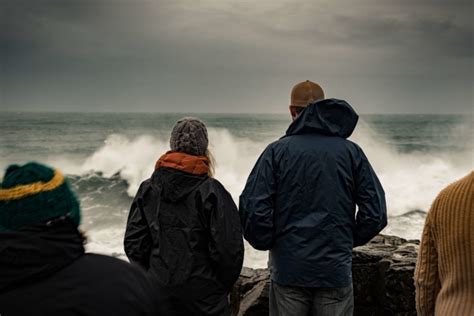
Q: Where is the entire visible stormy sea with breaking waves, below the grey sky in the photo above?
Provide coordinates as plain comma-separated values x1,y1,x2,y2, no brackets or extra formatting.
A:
0,112,474,266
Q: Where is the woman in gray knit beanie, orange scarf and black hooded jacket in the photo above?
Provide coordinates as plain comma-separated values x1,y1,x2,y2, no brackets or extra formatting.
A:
124,118,244,315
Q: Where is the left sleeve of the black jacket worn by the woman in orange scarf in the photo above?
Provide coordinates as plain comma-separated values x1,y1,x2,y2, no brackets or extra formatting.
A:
124,184,152,270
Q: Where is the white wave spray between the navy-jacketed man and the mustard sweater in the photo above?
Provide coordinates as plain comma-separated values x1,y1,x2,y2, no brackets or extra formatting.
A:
352,122,473,216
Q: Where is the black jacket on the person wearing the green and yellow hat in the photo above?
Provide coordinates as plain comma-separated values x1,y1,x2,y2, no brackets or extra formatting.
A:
0,220,158,316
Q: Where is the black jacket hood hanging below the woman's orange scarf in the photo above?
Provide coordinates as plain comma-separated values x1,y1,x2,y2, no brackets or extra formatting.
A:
151,167,209,202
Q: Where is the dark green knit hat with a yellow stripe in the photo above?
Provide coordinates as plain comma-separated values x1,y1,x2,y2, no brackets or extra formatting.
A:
0,162,81,231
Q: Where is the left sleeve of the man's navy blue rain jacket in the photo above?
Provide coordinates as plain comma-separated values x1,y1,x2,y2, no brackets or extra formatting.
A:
239,145,276,250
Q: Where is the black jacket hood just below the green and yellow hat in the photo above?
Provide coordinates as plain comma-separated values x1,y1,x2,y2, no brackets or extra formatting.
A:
0,218,84,292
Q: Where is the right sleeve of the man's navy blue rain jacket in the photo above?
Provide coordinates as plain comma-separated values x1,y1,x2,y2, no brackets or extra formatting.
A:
354,146,387,247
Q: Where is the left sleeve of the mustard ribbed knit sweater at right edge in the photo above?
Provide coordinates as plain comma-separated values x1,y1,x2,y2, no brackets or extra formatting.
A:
415,202,441,316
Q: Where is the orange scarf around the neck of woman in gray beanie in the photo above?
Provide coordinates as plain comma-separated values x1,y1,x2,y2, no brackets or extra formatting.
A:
155,151,209,175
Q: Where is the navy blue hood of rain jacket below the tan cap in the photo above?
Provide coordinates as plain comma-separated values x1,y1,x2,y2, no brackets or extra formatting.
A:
286,99,359,138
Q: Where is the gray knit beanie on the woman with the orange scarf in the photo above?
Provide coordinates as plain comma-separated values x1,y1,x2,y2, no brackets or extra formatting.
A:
170,117,209,156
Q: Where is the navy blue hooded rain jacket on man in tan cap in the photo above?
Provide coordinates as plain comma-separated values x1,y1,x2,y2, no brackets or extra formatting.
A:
240,99,387,288
